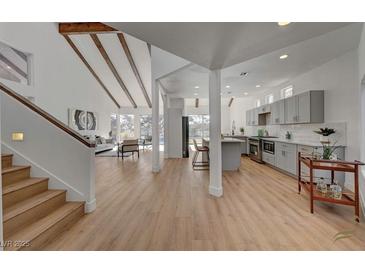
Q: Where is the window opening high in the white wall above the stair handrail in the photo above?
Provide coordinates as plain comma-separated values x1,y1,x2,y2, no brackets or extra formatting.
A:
0,42,31,85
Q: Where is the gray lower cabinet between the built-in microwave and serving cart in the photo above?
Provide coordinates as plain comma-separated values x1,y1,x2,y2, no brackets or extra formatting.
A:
275,142,297,175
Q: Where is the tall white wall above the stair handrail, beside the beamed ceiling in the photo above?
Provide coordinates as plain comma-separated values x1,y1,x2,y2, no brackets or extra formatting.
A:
0,23,117,136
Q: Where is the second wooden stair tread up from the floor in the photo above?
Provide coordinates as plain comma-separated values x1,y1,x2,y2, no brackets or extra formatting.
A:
3,190,66,222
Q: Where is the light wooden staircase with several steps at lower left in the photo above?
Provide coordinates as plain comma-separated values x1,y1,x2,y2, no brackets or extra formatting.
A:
1,154,84,250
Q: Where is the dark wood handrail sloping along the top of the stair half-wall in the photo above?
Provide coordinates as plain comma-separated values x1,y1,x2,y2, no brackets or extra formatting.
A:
0,82,95,148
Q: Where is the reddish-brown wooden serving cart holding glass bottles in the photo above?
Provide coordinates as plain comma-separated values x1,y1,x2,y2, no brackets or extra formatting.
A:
298,152,364,222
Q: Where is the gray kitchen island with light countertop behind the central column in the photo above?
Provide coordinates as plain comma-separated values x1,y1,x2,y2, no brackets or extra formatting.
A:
203,138,246,171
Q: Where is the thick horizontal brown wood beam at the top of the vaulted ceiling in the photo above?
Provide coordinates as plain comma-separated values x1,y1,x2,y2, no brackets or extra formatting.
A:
58,22,120,35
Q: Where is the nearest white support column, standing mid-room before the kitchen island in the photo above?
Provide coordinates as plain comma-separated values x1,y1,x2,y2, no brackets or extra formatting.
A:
209,70,223,197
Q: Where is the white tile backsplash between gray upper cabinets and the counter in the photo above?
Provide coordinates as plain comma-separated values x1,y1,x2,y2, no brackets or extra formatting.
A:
248,122,347,145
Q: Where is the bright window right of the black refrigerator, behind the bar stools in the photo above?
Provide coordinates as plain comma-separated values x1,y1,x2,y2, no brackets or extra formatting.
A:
189,115,210,144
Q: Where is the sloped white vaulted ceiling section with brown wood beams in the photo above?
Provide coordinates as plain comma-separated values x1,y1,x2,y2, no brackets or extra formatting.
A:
59,23,151,108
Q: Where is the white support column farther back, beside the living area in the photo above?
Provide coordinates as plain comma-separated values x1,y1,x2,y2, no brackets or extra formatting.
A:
152,79,160,172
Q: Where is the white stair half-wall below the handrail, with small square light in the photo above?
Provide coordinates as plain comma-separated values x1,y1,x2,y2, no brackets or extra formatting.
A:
0,92,96,212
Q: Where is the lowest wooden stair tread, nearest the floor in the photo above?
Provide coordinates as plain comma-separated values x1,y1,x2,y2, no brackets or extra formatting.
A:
5,202,84,250
